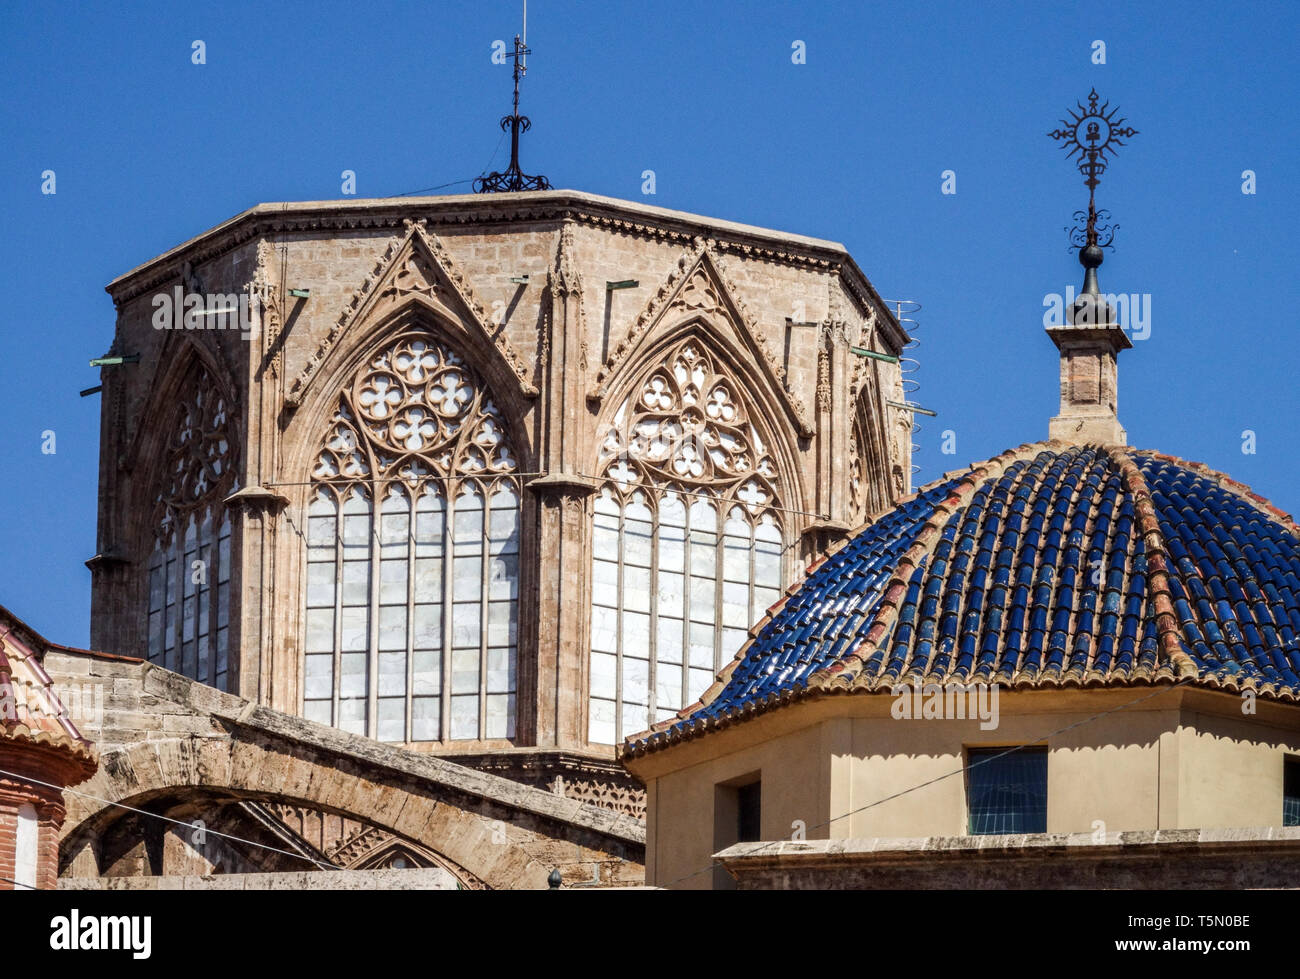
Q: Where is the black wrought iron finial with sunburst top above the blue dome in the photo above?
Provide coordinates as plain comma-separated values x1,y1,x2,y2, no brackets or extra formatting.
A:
1048,88,1138,294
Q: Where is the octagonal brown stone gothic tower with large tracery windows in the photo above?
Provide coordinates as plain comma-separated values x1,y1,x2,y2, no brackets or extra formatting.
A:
88,191,910,785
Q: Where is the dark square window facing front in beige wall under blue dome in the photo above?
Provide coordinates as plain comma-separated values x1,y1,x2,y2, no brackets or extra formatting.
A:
966,748,1048,835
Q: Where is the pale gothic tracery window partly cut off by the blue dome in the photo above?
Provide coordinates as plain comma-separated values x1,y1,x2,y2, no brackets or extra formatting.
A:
588,339,783,744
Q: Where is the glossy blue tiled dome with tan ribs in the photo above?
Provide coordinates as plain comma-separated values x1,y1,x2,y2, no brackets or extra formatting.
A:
627,442,1300,754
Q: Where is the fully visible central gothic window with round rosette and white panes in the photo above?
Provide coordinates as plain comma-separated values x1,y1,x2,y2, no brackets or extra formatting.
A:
303,332,520,741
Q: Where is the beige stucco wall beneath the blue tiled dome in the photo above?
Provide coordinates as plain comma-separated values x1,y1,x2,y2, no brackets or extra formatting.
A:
628,689,1300,887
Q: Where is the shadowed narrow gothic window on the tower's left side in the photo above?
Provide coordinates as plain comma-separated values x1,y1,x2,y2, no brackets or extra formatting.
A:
147,367,235,690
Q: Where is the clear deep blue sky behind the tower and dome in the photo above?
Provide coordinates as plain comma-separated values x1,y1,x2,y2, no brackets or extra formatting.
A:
0,0,1300,645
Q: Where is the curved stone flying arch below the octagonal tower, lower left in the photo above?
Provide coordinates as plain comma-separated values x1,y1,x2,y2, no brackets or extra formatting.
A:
60,731,639,889
